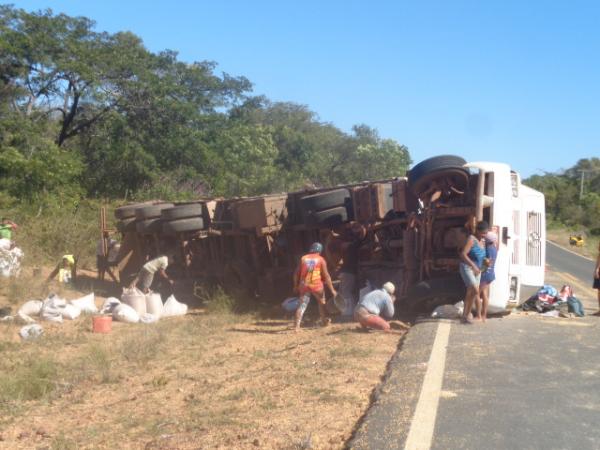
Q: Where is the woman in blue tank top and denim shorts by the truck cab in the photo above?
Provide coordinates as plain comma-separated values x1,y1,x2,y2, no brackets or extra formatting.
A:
459,221,489,323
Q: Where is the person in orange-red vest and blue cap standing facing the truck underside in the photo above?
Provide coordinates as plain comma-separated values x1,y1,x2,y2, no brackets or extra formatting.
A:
294,242,337,331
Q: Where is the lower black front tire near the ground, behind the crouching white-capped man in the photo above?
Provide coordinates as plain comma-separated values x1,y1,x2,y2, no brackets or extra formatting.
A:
406,275,466,313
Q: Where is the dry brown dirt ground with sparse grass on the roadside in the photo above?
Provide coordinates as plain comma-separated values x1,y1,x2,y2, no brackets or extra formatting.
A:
0,268,403,449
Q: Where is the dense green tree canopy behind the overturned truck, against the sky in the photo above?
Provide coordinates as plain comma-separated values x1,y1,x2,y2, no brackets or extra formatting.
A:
0,5,410,205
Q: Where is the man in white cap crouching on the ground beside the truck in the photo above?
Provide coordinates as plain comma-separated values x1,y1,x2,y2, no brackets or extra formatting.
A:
354,281,396,331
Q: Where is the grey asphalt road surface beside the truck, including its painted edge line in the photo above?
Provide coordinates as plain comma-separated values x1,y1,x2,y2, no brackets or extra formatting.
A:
349,244,600,450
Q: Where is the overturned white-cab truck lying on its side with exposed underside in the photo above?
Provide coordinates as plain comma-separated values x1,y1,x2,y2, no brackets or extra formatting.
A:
103,155,545,312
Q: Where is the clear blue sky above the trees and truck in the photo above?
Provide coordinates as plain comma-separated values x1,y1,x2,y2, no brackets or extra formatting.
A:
14,0,600,176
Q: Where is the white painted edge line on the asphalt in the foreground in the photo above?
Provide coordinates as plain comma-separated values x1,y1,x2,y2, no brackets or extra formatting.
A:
404,322,451,450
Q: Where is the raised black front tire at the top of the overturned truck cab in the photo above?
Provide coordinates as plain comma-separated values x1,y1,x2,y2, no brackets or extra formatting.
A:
408,155,469,195
